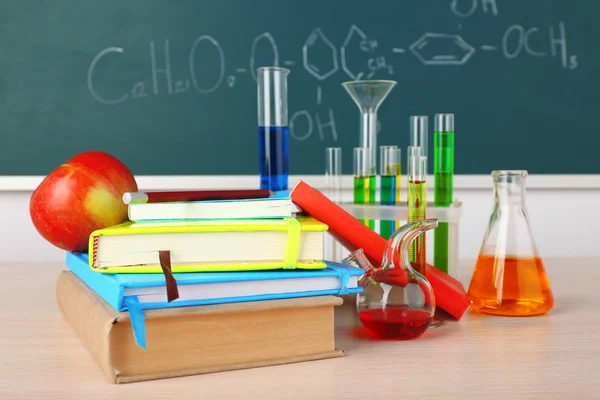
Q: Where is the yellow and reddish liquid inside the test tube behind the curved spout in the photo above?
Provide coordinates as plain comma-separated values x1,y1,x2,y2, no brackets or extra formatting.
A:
408,181,427,276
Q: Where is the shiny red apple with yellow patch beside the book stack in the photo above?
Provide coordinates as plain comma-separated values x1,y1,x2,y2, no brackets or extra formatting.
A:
29,151,137,252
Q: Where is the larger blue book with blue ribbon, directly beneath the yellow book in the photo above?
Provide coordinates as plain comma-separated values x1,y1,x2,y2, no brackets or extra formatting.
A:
66,252,364,349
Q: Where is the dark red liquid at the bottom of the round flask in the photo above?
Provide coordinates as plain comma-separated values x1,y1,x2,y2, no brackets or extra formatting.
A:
358,307,433,340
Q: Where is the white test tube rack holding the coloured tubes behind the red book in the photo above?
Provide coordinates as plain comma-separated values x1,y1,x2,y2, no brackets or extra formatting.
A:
338,201,463,279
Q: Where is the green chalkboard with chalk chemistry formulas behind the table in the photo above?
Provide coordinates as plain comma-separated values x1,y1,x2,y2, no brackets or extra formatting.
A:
0,0,600,175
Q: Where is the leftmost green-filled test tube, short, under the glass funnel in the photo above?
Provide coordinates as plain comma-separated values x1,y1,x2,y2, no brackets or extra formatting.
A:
354,147,377,230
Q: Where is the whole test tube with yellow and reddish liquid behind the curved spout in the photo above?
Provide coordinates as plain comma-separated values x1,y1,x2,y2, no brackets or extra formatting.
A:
406,146,427,276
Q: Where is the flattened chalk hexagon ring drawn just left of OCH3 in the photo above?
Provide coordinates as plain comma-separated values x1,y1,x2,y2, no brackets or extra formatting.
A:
410,32,475,65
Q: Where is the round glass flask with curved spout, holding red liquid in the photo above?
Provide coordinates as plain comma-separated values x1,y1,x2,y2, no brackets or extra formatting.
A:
343,219,438,340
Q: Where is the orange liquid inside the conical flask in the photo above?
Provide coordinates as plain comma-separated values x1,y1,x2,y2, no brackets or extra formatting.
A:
469,255,554,316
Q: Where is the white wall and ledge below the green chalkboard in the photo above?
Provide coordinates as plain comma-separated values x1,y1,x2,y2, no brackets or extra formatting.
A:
0,176,600,274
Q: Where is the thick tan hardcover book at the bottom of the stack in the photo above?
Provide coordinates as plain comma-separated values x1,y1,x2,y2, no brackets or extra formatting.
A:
56,271,344,383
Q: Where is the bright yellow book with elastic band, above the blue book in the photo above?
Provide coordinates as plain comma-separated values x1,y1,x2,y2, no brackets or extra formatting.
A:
89,216,328,273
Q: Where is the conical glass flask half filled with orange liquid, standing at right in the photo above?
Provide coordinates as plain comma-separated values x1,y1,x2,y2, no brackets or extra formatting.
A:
468,171,554,316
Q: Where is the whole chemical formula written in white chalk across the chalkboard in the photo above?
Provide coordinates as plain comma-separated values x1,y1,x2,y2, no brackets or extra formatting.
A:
87,0,579,141
